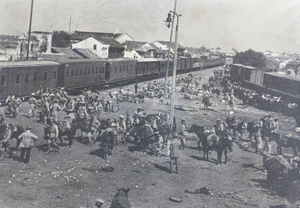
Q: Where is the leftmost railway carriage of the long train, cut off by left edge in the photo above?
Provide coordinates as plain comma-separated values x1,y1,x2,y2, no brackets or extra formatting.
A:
0,61,60,100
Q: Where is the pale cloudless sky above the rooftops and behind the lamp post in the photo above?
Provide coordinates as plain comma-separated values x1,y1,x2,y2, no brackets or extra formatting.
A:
0,0,300,53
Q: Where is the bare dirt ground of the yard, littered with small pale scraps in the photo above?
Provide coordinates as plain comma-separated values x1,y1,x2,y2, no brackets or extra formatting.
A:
0,69,299,208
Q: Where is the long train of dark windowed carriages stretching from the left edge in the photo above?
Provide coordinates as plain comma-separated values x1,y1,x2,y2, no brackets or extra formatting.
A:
0,57,225,101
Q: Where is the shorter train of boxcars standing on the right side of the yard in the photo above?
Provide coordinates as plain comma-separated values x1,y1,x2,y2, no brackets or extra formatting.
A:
229,64,300,98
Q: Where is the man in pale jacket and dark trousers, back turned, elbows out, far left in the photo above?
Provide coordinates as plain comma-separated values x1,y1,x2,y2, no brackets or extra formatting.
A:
18,126,38,163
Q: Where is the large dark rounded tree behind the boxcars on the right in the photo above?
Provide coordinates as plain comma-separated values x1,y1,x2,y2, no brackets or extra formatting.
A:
233,49,267,68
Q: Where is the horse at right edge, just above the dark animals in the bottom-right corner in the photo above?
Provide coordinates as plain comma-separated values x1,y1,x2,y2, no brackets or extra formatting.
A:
270,133,300,157
